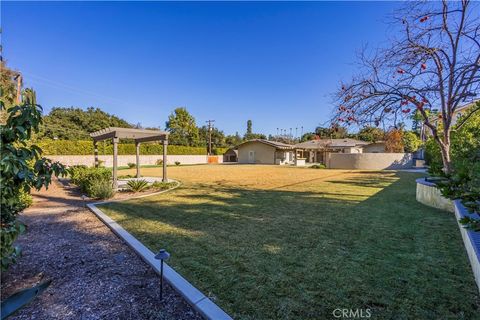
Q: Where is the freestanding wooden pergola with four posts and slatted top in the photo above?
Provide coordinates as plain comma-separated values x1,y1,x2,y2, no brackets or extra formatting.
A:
90,127,168,189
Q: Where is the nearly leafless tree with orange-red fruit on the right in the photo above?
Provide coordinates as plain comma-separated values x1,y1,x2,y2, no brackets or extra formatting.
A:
333,0,480,173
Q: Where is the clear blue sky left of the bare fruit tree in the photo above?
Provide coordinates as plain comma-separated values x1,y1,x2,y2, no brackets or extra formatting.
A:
1,1,400,134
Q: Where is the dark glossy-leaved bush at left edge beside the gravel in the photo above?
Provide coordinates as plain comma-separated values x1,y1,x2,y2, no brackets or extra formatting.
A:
0,102,65,270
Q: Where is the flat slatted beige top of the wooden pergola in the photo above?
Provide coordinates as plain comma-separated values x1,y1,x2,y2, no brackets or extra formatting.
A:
90,127,169,142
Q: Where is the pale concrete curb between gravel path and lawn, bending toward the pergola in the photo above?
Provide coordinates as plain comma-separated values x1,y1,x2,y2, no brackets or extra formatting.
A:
87,183,232,320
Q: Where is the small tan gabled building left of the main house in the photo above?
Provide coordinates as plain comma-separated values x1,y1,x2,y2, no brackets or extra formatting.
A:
237,139,295,164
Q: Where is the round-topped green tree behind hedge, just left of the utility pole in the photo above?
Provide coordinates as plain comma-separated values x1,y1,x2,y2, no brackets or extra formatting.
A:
166,108,199,146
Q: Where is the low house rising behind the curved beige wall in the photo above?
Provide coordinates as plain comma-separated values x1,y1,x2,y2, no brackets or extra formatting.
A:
295,138,385,164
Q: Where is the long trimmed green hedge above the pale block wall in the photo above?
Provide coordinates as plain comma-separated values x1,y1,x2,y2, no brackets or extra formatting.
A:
36,140,227,156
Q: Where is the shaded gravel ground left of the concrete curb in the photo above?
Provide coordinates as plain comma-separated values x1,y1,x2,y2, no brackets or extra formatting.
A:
1,182,201,319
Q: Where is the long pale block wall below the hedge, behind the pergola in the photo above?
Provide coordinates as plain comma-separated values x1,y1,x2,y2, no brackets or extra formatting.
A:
45,155,223,167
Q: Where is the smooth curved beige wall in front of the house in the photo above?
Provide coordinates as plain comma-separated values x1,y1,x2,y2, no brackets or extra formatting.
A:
326,153,413,170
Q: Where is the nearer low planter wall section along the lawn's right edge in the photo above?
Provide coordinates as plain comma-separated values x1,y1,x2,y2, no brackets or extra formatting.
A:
453,200,480,291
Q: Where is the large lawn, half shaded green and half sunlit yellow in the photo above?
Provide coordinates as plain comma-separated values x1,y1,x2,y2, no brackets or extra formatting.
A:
101,165,480,319
